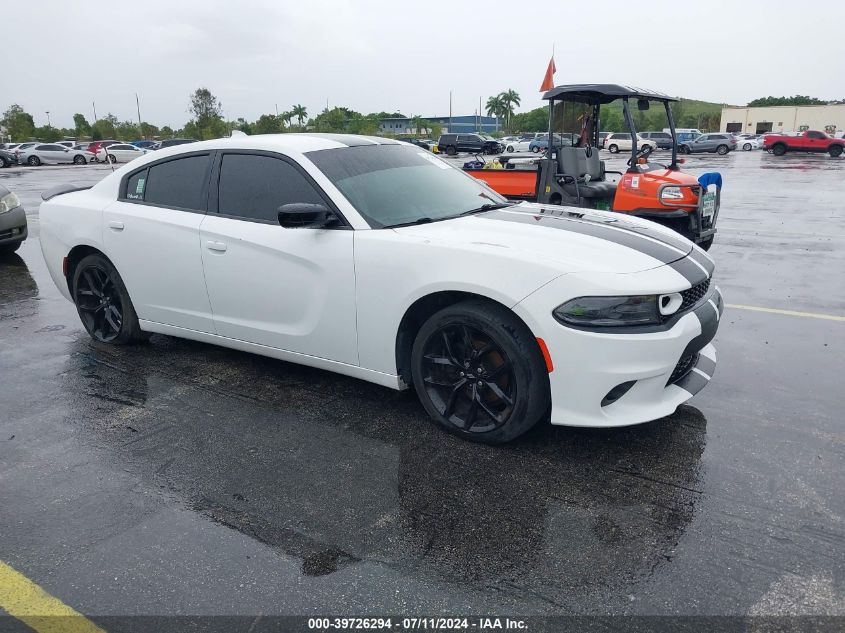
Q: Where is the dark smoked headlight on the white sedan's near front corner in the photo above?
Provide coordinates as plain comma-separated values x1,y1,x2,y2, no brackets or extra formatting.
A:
553,295,660,327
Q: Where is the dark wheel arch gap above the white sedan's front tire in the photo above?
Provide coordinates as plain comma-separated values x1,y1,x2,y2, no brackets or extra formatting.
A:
395,290,543,385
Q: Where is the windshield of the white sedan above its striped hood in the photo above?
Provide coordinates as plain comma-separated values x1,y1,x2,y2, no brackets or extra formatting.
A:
305,145,506,228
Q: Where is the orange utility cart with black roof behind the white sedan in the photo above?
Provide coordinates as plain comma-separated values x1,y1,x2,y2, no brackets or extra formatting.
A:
465,84,722,250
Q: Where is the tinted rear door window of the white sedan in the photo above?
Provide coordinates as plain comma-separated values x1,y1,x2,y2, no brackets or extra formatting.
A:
143,156,211,211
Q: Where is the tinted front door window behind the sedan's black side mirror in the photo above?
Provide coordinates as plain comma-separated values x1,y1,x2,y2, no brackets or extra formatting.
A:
218,154,325,224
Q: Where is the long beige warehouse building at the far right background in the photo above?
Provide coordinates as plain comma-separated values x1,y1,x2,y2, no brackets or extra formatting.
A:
719,104,845,134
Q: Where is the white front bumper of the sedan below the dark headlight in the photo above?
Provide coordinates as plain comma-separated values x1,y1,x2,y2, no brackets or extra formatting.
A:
518,270,724,427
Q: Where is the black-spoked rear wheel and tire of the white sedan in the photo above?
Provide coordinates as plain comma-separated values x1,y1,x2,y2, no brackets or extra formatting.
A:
72,254,146,345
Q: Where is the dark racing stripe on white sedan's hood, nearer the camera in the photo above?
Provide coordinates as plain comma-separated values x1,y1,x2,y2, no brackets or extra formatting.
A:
476,211,684,271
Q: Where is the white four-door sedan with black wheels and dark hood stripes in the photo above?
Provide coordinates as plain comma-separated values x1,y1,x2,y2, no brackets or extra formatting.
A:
40,134,723,443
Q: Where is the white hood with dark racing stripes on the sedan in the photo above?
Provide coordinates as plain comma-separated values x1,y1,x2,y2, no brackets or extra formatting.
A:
394,203,692,273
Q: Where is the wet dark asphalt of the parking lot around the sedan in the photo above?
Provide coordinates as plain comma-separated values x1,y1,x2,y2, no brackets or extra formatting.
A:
0,152,845,616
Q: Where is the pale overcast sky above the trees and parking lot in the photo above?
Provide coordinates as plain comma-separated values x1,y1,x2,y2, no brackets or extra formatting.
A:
6,0,845,128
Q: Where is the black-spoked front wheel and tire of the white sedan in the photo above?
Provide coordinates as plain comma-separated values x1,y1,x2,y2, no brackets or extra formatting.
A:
411,300,551,444
